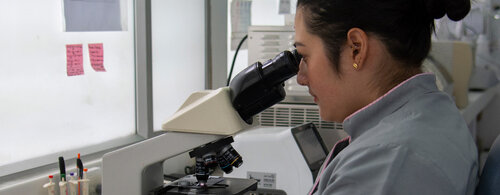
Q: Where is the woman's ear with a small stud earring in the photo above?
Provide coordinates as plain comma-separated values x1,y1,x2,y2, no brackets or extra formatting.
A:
347,28,368,70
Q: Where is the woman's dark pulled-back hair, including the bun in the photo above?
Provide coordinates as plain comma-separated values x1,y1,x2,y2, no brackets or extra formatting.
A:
297,0,470,71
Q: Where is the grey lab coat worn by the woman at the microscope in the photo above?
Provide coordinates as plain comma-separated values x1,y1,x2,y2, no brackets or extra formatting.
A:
315,73,478,195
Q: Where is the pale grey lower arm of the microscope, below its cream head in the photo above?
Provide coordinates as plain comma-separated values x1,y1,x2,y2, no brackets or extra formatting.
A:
102,132,224,195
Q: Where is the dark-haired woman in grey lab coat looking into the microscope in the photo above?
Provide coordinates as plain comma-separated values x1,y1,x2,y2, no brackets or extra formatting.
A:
295,0,478,195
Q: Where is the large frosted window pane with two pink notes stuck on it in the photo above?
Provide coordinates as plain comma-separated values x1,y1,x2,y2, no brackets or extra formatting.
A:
0,0,135,166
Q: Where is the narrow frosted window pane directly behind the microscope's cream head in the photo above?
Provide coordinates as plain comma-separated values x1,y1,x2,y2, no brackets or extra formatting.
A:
151,0,205,130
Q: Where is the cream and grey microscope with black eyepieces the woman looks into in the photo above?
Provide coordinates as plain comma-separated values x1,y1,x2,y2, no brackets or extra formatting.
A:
102,50,302,195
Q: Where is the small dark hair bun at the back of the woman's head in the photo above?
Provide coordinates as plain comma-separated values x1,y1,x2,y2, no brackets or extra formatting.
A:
425,0,470,21
